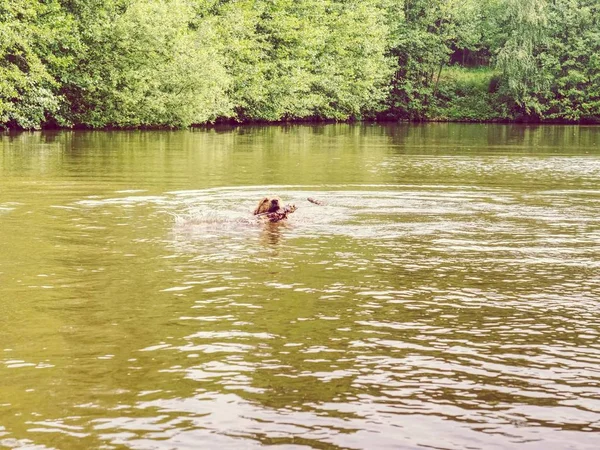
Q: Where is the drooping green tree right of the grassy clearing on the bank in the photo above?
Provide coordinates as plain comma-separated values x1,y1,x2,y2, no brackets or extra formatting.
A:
498,0,600,121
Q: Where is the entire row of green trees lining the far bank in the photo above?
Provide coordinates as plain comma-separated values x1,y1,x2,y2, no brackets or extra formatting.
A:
0,0,600,129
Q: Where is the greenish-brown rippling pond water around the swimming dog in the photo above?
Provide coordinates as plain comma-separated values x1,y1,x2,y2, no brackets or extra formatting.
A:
0,124,600,450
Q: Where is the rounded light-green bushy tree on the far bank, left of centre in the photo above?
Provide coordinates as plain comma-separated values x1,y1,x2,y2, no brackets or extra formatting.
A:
63,0,230,127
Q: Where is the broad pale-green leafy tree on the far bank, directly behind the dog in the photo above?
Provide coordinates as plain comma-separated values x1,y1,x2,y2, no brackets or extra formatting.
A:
220,0,391,120
